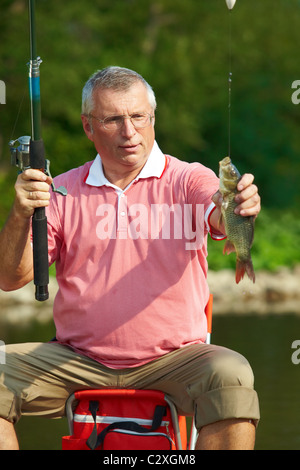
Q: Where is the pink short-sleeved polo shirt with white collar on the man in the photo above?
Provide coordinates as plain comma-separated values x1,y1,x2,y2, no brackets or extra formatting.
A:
47,143,219,368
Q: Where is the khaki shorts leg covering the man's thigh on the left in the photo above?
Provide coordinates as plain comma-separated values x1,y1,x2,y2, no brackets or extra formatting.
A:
0,343,117,422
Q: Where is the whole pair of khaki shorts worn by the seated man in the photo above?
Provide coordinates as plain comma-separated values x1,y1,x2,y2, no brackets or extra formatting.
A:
0,343,259,429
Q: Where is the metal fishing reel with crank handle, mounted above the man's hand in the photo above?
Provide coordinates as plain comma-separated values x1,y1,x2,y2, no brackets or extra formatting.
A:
8,135,67,196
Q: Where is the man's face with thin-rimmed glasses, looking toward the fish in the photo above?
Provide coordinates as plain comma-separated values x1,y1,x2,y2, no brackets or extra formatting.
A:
82,82,155,179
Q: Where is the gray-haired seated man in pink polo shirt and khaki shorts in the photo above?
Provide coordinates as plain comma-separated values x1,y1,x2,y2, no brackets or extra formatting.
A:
0,67,260,449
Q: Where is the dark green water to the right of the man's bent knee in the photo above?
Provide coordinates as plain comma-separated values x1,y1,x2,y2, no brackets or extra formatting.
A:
213,315,300,450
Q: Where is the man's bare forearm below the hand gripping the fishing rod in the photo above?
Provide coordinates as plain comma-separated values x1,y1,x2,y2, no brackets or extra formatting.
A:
0,209,33,291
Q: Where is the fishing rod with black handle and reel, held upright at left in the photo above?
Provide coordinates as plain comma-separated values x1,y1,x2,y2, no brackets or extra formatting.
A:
9,0,66,301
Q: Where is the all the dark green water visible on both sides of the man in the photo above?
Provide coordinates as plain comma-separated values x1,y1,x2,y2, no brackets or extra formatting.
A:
1,314,300,450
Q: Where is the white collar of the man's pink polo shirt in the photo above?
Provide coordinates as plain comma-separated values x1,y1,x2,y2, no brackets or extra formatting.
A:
85,141,166,186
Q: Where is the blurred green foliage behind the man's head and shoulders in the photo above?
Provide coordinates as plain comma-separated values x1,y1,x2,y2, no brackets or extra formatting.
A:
0,0,300,269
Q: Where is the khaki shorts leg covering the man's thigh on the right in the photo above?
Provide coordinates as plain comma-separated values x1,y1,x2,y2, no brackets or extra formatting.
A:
119,344,259,428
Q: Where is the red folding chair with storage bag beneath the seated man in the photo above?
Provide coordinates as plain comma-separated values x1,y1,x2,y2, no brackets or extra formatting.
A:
62,295,213,450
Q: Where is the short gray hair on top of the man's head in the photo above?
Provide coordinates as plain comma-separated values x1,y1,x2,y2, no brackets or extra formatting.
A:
81,66,156,115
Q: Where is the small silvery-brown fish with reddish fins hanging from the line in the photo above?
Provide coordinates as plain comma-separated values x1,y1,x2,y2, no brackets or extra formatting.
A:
219,157,255,284
